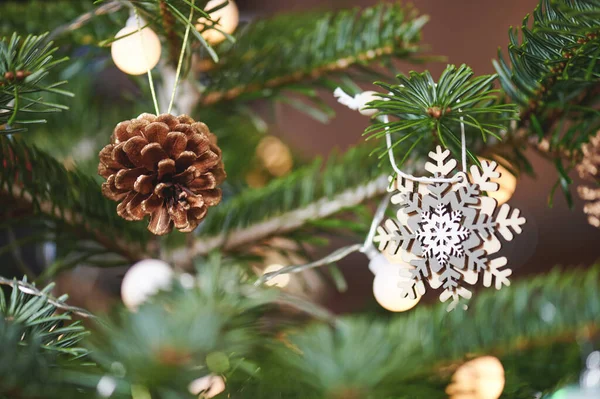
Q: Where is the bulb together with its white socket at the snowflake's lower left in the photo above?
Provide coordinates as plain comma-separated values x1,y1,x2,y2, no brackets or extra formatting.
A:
369,253,421,312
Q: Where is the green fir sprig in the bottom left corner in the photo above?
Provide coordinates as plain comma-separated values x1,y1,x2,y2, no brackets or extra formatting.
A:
0,278,90,399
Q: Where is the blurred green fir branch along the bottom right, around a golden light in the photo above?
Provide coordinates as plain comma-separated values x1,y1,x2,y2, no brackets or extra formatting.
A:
228,266,600,399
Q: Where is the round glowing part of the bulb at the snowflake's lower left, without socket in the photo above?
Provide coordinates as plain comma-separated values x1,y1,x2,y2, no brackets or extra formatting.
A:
373,265,421,312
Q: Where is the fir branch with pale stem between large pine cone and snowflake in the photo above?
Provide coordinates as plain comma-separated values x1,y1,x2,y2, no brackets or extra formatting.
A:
169,145,389,263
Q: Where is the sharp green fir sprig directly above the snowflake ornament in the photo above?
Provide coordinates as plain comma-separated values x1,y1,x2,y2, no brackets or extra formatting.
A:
365,65,517,163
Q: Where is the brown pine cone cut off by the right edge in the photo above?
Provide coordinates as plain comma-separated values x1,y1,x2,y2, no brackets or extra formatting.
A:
577,132,600,227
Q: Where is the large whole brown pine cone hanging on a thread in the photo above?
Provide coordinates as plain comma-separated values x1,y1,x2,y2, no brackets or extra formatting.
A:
98,114,226,235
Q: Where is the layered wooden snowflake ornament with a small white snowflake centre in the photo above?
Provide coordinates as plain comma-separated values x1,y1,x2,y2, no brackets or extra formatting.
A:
374,146,525,311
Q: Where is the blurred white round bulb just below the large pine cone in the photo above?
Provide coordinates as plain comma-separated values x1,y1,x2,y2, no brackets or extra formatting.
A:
121,259,173,311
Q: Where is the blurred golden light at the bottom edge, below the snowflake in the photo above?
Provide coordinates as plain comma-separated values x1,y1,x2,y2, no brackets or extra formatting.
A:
446,356,505,399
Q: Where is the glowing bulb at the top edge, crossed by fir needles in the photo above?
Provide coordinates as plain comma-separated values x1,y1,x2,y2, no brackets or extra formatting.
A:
196,0,240,44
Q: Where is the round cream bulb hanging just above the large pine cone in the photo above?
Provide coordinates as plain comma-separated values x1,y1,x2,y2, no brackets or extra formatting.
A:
110,16,161,75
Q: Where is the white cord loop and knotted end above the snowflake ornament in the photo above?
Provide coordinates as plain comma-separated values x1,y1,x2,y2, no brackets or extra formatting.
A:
333,87,467,183
